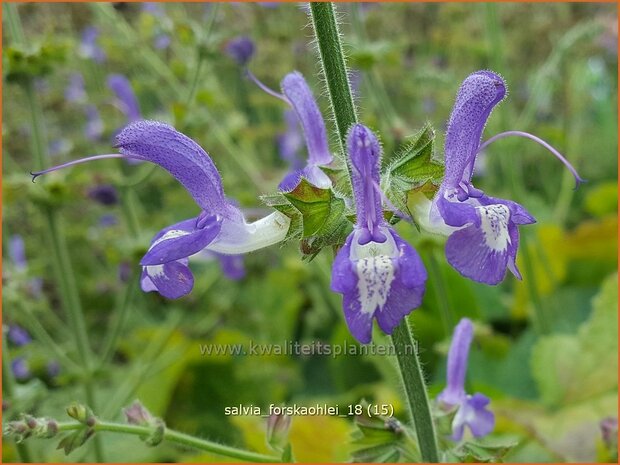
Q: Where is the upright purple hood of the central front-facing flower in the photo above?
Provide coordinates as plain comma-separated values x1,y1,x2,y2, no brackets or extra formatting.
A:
347,124,385,244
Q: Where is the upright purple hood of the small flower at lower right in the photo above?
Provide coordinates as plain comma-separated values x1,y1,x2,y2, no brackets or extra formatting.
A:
437,318,474,407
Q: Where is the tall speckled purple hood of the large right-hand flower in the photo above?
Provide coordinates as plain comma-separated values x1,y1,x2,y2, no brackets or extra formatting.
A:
442,71,506,187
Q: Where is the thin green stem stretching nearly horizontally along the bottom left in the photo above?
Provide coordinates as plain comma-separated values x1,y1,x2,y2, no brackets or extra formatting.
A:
58,420,280,463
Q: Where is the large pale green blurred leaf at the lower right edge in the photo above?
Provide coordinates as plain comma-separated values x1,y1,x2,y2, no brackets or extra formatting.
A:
531,274,618,406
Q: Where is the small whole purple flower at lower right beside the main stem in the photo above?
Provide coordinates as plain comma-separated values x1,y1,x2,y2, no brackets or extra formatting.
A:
437,318,495,441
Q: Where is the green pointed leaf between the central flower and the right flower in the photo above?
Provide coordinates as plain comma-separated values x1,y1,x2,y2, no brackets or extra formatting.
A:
381,124,444,216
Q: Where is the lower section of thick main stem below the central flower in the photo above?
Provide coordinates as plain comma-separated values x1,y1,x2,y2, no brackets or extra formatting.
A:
392,318,439,463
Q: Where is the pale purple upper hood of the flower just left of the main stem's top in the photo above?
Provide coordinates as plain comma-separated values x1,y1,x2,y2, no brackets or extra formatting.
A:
281,71,333,165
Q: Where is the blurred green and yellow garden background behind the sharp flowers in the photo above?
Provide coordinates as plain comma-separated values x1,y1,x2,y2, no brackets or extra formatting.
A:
2,3,618,462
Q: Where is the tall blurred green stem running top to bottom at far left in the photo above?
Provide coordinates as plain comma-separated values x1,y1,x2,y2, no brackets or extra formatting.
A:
6,4,104,462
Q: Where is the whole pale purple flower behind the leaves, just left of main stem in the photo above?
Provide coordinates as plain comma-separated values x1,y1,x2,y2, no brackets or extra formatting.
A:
278,71,333,192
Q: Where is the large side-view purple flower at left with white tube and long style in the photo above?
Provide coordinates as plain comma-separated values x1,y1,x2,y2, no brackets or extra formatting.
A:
33,121,290,299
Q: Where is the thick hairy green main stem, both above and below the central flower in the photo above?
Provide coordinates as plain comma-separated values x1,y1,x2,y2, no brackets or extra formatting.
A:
310,2,439,462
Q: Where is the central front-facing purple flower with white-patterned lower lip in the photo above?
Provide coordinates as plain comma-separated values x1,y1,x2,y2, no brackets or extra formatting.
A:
331,124,426,344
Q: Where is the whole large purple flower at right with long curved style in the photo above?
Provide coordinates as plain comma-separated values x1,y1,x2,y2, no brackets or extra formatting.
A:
419,71,581,284
